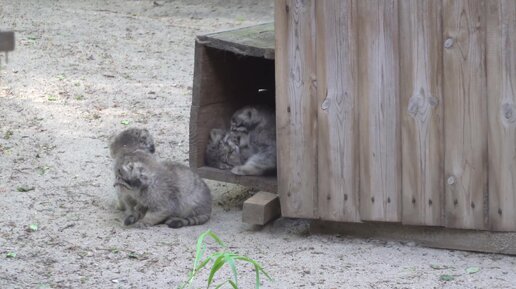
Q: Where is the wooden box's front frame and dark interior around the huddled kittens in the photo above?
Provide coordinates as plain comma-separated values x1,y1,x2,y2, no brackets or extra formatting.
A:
189,25,277,192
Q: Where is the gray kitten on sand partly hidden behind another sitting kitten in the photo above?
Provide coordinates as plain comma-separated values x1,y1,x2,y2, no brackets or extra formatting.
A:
109,128,155,211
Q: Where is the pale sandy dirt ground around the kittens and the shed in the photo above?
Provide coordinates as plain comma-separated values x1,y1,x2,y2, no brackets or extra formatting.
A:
0,0,516,288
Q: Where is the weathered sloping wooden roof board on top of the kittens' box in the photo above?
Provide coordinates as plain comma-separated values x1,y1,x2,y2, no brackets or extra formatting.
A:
197,23,274,59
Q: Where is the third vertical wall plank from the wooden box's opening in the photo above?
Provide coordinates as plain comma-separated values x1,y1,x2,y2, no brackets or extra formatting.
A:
355,0,401,222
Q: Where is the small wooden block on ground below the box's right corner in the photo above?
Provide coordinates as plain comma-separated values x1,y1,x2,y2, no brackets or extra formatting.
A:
242,191,281,225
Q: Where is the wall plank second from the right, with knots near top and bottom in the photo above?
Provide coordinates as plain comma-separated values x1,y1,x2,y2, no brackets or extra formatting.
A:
443,0,488,229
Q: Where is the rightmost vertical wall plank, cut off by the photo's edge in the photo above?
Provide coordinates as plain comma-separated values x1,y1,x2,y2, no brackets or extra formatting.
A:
486,0,516,231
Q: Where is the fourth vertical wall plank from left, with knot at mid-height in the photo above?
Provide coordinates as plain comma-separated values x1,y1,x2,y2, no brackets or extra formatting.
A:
399,0,444,226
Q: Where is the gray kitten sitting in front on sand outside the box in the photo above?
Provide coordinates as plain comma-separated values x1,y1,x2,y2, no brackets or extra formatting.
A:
115,150,212,228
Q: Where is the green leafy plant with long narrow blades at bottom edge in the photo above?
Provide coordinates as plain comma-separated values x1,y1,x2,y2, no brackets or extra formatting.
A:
178,230,272,289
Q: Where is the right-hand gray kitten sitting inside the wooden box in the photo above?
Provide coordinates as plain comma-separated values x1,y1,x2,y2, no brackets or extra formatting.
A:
230,106,276,175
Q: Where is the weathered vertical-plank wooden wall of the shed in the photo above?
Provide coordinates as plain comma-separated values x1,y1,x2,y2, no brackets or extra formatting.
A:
275,0,516,231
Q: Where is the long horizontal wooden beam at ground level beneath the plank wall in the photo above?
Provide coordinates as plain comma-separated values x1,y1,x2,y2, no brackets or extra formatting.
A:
310,220,516,255
